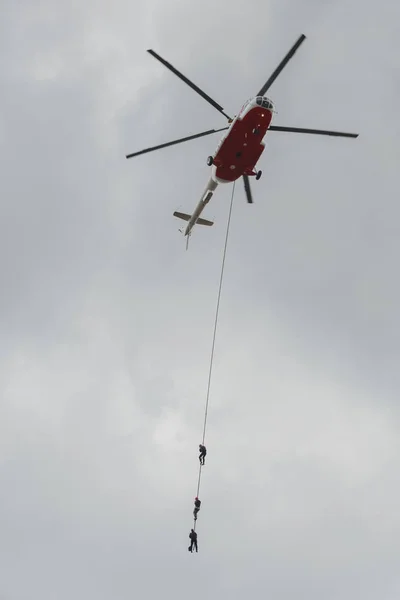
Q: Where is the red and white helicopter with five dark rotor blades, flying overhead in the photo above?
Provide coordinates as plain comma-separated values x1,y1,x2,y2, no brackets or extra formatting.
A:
126,35,358,241
